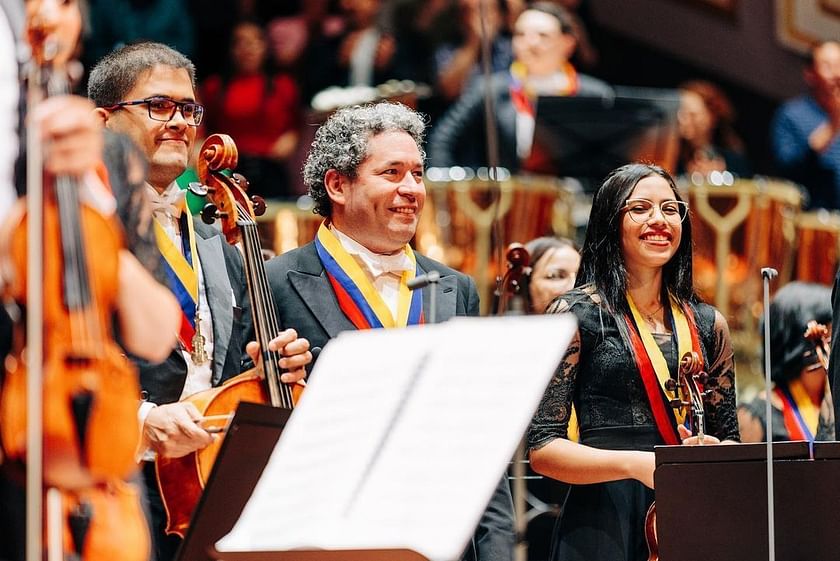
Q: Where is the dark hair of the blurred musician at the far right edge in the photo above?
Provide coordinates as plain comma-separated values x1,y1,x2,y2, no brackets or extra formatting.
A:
769,281,832,384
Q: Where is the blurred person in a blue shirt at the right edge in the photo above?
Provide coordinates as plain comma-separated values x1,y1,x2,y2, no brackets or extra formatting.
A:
771,41,840,209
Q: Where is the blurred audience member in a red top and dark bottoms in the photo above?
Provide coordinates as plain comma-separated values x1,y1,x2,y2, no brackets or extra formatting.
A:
201,21,302,197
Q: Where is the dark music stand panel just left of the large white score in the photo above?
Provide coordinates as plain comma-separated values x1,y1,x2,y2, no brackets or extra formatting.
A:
175,402,291,561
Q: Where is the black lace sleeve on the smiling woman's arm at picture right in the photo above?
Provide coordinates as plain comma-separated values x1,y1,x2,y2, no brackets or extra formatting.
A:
706,310,740,442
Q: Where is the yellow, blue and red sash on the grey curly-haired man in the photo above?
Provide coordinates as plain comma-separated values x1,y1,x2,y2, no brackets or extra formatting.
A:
315,222,423,329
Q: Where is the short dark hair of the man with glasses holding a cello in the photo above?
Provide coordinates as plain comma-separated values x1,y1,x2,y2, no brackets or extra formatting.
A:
88,41,195,107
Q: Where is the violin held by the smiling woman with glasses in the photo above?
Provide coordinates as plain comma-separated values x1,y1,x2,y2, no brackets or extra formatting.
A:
645,351,717,561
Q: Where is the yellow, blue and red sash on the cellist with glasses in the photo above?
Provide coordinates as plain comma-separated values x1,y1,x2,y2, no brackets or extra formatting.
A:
154,211,198,352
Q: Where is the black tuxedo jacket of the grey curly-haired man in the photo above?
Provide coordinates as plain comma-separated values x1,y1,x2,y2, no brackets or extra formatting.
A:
266,242,514,561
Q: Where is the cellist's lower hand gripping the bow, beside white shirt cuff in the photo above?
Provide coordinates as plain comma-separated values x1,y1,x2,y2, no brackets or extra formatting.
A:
143,401,214,458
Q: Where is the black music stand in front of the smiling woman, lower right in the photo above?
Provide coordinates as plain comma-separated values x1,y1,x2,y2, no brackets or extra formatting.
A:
654,442,840,561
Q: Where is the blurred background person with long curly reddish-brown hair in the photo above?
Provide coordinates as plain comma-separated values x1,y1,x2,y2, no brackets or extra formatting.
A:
677,80,752,177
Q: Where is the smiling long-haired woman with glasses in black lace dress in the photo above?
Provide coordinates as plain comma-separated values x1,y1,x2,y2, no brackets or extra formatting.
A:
528,164,739,561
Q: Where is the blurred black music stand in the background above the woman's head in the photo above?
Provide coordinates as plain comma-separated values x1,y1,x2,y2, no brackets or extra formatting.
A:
522,87,679,183
